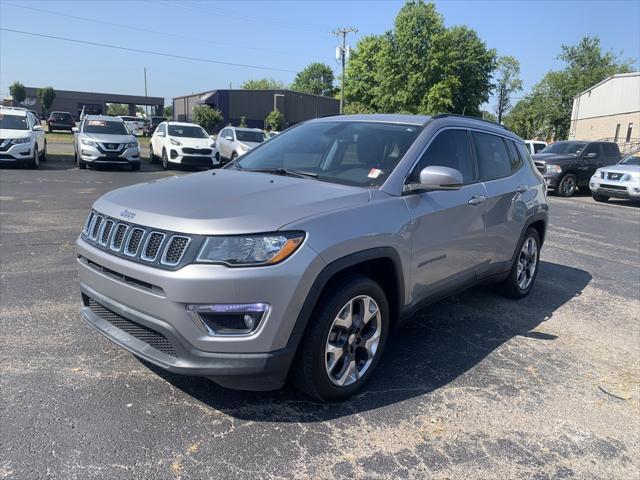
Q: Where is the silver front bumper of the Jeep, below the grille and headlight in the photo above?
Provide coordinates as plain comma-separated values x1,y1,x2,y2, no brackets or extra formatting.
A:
77,239,324,390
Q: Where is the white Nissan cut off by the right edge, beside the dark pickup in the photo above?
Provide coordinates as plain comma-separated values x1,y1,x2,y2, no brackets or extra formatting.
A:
589,152,640,202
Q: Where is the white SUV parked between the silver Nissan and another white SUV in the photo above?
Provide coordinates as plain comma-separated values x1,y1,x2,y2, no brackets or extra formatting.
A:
149,122,220,170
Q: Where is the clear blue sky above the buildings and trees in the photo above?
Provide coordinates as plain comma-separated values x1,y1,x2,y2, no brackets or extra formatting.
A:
0,0,640,109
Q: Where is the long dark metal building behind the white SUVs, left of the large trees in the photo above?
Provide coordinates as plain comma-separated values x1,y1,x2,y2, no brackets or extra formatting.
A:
173,90,340,128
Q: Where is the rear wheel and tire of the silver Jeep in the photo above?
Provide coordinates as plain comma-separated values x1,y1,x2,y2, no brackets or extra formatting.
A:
498,227,540,299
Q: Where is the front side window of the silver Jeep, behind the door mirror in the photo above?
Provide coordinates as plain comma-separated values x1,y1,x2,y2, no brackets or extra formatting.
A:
409,130,473,183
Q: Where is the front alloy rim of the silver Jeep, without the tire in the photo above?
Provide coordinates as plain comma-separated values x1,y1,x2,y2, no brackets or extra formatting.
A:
325,295,382,387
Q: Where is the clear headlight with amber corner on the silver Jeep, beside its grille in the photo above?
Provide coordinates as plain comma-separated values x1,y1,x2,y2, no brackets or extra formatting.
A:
197,232,304,266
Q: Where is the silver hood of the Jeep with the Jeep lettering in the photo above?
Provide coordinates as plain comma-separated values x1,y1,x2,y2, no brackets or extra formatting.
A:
93,170,369,235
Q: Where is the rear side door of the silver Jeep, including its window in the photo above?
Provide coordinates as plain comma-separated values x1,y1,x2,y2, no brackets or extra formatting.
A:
471,131,532,277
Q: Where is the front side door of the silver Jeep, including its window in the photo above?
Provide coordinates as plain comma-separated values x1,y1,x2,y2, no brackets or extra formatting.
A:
405,128,489,301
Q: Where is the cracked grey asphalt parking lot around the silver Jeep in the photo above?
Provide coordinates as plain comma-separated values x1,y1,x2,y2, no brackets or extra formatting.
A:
0,145,640,480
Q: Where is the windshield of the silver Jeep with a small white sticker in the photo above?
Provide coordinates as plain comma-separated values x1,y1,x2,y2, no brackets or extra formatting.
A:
229,121,420,187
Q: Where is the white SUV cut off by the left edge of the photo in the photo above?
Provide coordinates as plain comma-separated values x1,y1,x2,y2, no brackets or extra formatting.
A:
0,107,47,168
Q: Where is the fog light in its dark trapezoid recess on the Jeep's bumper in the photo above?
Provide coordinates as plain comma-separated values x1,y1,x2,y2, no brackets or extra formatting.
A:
187,303,269,336
